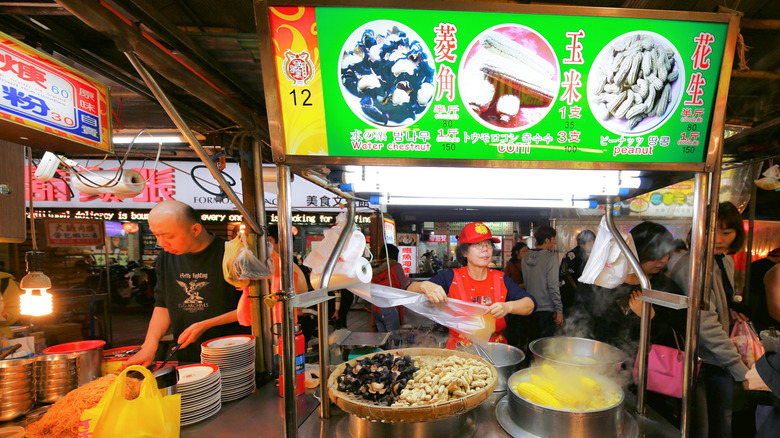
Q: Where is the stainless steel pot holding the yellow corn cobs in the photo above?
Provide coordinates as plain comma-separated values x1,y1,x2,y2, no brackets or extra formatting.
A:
508,368,626,438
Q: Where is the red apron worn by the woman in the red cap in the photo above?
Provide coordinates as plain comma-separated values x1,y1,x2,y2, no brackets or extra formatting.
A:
447,266,507,350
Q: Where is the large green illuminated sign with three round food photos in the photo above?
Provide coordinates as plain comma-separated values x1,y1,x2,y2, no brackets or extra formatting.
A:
268,1,737,170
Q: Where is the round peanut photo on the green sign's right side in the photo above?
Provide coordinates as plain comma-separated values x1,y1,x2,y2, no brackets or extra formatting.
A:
588,31,685,135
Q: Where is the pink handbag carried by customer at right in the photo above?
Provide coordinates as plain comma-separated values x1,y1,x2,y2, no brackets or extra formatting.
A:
633,332,701,398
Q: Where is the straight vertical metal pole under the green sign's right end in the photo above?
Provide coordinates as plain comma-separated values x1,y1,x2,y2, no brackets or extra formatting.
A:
680,173,714,438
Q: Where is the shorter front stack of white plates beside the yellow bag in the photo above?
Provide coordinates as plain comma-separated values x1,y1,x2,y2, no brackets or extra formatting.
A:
176,364,222,426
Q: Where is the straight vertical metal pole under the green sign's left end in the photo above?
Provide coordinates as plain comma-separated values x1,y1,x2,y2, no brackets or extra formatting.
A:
276,163,298,438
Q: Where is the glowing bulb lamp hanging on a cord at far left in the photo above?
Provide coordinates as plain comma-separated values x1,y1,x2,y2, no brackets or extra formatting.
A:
19,147,53,316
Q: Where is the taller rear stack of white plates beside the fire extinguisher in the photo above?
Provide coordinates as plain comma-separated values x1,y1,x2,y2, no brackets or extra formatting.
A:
200,335,255,402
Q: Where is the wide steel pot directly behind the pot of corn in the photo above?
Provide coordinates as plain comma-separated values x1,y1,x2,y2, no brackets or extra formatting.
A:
528,336,626,374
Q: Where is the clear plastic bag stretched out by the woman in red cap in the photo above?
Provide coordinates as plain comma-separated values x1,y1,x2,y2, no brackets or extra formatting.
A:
349,283,495,344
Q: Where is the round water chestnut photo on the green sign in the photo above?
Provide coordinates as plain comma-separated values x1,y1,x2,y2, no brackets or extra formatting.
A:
339,20,435,128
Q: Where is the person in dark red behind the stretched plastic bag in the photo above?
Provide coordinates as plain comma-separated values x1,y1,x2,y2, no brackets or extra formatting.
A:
371,244,409,332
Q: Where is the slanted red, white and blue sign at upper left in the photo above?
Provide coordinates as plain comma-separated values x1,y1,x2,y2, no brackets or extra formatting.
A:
0,32,113,152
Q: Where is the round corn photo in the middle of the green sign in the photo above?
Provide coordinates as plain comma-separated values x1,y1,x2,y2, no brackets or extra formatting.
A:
458,24,560,132
